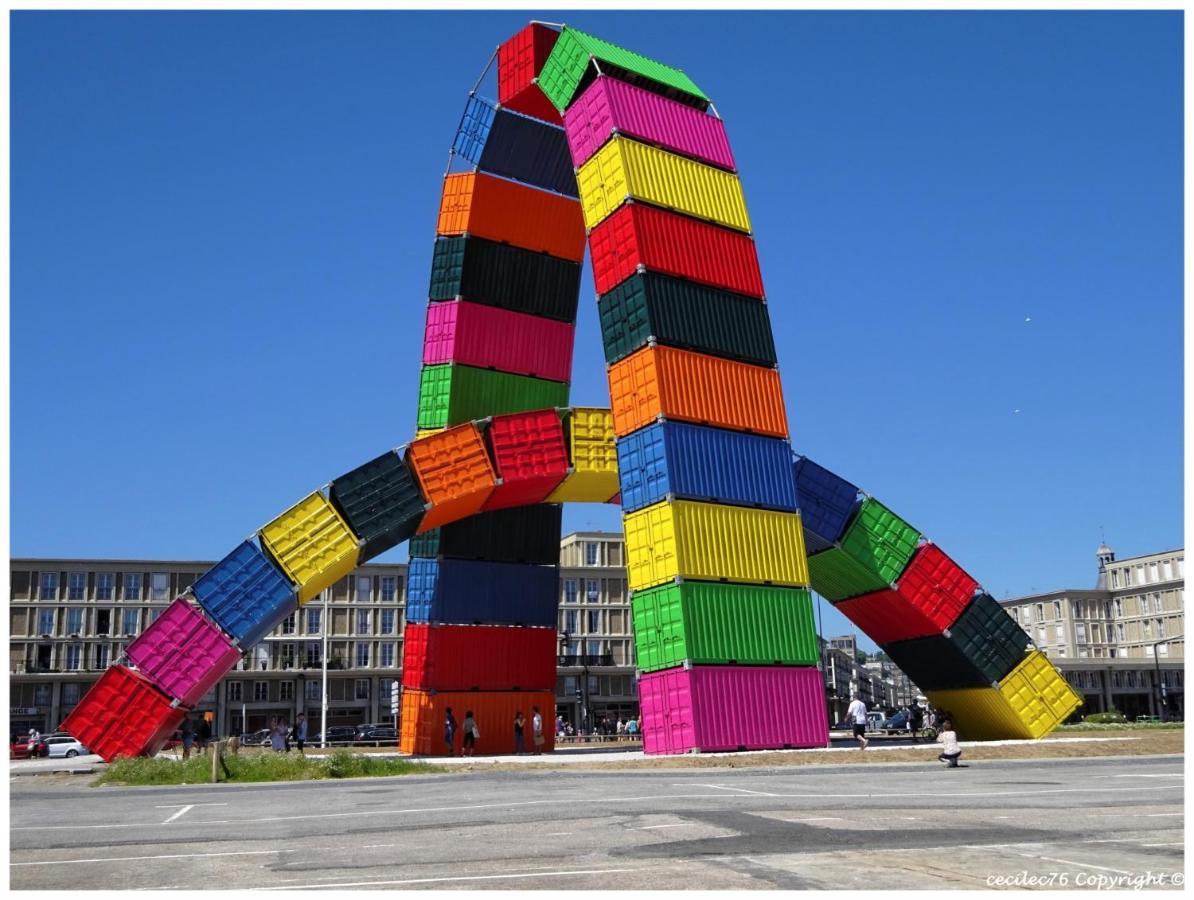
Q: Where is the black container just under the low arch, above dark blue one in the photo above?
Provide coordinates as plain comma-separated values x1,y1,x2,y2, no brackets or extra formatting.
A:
411,504,564,566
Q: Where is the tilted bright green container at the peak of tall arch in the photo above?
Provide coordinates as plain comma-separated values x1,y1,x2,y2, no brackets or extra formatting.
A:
538,27,709,112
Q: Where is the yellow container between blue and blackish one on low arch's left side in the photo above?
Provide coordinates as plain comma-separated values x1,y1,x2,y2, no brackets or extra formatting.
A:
261,491,361,603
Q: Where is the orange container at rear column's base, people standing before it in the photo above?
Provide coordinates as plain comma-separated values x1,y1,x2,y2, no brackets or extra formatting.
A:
398,689,555,757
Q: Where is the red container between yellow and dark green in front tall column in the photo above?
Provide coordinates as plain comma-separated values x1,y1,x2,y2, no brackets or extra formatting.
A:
589,202,763,297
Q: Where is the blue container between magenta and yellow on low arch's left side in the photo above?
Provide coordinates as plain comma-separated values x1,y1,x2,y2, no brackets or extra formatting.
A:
191,541,299,647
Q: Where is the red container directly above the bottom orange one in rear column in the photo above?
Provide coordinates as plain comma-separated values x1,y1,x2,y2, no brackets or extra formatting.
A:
402,623,556,691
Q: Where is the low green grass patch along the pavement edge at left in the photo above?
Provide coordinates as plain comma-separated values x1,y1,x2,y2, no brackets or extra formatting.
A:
93,750,443,785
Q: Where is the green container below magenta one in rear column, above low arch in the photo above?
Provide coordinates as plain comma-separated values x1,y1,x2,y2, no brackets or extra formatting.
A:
419,363,568,429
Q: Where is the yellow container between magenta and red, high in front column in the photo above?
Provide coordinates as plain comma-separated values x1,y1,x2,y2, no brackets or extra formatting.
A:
577,137,750,233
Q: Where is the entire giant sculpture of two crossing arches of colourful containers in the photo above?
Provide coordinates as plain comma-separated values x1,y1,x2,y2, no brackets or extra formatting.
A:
63,24,1079,759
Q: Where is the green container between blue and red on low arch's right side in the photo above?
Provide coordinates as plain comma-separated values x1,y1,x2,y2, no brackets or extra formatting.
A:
808,497,921,603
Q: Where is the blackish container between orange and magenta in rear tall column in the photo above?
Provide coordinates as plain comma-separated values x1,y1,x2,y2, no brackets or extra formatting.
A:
429,236,580,322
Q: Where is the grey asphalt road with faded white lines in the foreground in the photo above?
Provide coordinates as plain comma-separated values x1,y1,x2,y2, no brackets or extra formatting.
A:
10,757,1184,892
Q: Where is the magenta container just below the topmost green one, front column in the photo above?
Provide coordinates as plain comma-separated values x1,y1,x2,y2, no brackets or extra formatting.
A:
564,75,734,169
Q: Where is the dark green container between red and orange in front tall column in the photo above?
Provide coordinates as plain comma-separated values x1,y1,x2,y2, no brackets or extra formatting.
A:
597,272,776,365
